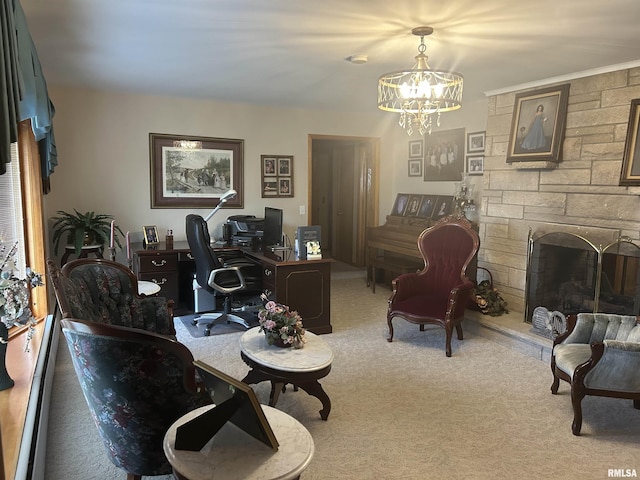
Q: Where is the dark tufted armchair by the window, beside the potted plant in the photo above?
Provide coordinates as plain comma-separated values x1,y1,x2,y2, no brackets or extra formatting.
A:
47,258,176,337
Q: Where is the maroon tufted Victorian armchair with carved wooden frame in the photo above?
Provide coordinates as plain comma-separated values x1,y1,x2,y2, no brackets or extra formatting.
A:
387,215,480,357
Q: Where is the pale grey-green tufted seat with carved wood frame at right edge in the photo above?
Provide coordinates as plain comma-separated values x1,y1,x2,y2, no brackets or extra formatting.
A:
551,313,640,435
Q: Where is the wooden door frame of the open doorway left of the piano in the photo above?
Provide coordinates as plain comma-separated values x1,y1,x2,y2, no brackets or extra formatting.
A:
307,134,380,266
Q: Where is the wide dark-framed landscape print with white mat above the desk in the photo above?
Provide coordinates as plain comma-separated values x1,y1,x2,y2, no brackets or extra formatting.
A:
149,133,244,208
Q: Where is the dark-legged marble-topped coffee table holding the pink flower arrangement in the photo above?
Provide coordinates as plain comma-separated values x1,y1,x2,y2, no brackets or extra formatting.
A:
240,327,333,420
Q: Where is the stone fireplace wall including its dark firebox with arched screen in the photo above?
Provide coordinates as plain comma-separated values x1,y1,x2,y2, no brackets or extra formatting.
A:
476,68,640,321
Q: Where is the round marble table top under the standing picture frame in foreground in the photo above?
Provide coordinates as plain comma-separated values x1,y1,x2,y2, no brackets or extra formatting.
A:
163,405,315,480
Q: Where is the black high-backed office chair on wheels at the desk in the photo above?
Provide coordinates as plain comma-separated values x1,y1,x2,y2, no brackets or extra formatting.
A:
186,214,257,335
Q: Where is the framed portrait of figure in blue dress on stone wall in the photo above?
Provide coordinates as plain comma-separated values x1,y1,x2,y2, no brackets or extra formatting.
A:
507,83,569,163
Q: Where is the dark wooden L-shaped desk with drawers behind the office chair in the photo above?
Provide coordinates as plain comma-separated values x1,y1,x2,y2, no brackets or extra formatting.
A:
131,241,333,334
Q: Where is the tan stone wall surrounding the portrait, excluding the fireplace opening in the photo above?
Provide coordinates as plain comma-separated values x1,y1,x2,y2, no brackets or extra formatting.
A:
478,68,640,319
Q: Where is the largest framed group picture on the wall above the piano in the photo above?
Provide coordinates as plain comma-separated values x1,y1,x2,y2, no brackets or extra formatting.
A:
423,128,465,182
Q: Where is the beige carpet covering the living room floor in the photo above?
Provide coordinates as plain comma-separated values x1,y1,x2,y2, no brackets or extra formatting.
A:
46,269,640,480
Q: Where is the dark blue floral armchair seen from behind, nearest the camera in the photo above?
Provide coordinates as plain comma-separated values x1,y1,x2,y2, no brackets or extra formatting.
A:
60,318,212,479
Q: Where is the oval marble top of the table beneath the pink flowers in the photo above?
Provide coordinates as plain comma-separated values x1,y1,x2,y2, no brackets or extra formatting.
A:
240,327,333,373
